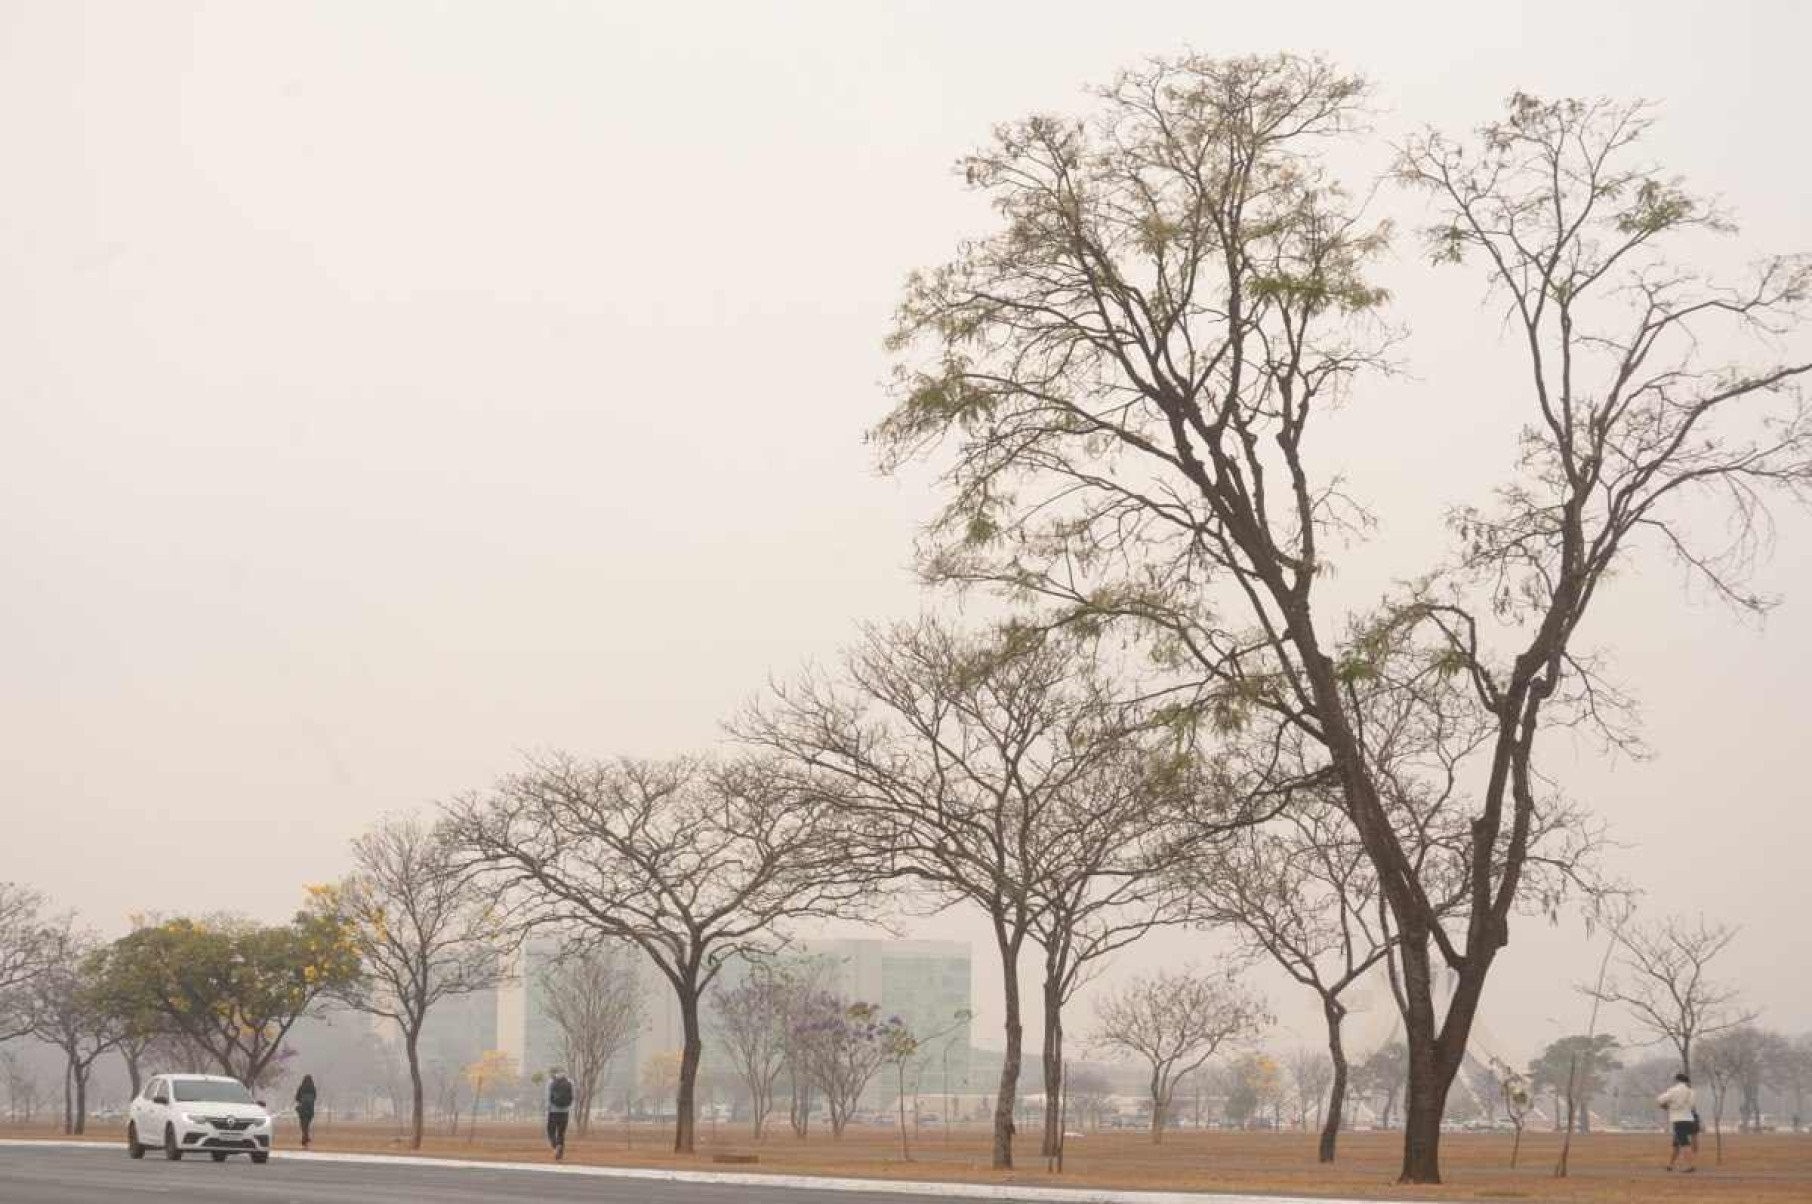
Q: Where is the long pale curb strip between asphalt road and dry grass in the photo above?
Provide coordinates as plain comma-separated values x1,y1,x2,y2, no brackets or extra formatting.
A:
0,1139,1412,1204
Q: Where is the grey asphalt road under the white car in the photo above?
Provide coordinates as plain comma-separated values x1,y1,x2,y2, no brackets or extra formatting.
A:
0,1146,1050,1204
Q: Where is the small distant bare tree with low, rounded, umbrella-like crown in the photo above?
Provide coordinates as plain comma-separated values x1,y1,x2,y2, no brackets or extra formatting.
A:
1093,970,1270,1142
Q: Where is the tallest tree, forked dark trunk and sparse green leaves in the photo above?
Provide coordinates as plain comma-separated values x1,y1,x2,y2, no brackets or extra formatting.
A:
877,56,1812,1182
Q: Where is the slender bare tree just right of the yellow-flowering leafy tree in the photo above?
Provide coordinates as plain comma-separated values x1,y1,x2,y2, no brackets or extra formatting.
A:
313,816,507,1150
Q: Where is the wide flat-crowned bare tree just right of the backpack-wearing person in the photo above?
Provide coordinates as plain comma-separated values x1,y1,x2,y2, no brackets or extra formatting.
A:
448,756,857,1153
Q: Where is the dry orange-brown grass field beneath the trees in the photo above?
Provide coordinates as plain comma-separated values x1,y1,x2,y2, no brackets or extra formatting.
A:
0,1121,1812,1204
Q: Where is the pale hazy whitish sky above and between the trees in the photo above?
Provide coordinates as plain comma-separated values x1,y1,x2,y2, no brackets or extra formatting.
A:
0,0,1812,1066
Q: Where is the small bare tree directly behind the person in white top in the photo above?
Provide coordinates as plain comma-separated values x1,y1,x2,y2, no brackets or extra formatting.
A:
1587,916,1756,1073
